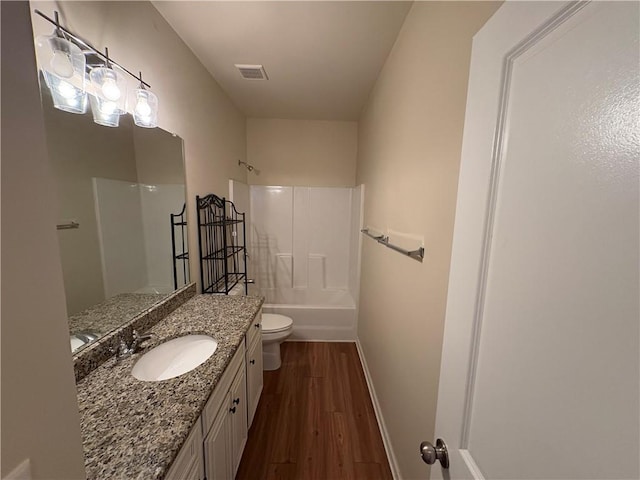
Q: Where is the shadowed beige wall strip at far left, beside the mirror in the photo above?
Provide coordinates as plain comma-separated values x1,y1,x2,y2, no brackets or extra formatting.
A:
0,2,84,480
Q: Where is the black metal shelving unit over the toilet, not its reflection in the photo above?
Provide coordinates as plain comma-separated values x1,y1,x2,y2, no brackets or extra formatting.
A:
196,194,248,295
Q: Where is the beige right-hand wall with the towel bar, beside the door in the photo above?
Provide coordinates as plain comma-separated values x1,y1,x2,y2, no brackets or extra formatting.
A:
357,2,499,479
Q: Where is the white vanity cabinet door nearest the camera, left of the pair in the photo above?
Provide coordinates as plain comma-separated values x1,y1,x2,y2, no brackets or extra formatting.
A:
204,395,233,480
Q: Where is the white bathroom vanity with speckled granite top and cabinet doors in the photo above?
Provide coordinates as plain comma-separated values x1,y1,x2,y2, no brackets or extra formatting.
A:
77,295,263,480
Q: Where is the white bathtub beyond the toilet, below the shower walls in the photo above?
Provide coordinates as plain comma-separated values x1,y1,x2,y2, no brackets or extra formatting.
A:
260,288,357,342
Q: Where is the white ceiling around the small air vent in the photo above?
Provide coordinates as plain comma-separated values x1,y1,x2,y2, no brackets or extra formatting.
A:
153,1,411,120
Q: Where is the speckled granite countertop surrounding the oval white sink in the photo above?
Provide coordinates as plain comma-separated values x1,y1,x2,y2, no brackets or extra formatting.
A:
77,295,263,480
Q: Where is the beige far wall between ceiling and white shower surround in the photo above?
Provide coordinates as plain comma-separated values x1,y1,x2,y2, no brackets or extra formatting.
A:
247,118,358,187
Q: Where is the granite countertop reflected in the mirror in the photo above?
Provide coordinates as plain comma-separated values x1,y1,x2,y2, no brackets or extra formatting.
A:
69,293,168,334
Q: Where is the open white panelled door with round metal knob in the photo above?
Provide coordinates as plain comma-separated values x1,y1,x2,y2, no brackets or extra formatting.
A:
425,2,640,480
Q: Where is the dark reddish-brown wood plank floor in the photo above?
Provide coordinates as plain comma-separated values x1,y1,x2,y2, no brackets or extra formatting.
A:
236,342,393,480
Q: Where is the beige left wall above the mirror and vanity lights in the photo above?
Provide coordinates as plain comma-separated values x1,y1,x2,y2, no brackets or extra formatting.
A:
32,1,247,288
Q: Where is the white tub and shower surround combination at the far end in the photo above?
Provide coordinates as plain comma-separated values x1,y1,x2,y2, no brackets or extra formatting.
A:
245,185,363,341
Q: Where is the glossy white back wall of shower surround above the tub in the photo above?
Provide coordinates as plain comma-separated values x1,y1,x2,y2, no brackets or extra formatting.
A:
250,185,353,301
